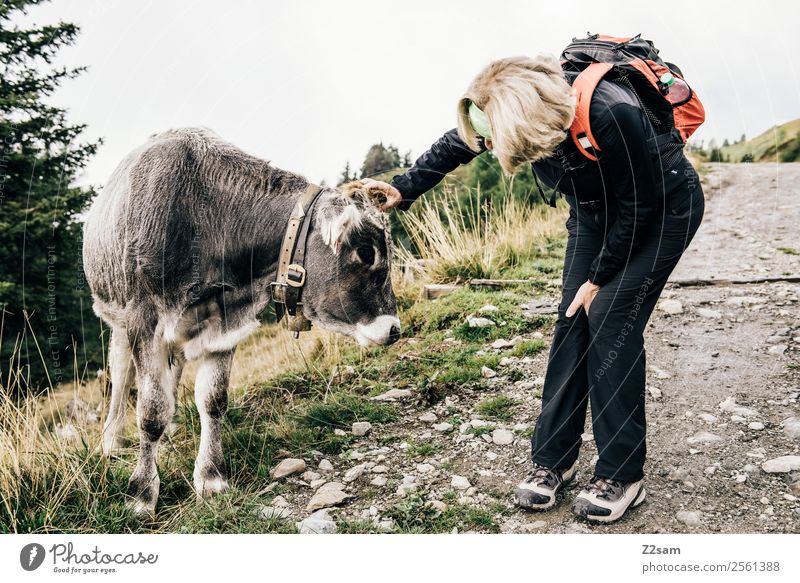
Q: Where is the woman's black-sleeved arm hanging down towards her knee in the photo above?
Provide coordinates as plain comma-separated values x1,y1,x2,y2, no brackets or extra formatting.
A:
589,103,660,286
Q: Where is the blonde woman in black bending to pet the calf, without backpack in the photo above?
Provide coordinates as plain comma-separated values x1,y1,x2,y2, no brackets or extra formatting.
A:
368,55,704,522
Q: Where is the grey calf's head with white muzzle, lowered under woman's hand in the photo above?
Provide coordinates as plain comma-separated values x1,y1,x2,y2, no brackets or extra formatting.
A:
303,181,400,346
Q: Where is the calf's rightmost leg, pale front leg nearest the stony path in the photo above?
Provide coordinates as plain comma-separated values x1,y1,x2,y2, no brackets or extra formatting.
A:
194,350,233,497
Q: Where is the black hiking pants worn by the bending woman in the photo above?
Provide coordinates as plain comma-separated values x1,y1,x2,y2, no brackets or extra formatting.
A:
532,177,704,482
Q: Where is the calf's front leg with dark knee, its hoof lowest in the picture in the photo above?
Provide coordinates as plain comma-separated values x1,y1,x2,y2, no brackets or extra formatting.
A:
128,340,181,515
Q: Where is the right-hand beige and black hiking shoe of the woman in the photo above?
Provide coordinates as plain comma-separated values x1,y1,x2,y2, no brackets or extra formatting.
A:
572,476,645,522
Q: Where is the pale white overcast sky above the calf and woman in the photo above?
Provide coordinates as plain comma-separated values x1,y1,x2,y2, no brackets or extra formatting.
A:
12,0,800,184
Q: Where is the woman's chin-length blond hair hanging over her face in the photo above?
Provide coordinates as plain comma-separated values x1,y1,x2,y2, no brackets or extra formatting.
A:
458,54,575,174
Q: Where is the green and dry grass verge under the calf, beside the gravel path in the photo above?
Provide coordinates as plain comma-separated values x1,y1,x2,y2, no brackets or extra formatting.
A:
0,179,565,533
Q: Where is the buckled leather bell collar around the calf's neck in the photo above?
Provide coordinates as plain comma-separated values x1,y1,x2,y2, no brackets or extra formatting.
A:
272,184,322,321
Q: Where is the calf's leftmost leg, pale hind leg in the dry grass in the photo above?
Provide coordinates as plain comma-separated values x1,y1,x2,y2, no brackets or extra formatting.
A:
103,328,135,456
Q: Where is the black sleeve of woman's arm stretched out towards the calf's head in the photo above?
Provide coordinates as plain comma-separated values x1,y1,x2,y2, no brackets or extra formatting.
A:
391,129,486,210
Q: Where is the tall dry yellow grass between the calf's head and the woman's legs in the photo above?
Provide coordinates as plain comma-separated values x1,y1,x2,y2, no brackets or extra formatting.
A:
397,192,566,283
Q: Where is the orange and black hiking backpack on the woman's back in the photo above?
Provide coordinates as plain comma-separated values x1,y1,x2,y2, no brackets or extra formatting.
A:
561,34,705,160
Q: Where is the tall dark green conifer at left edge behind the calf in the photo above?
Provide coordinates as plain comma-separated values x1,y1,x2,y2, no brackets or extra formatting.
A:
0,0,99,390
